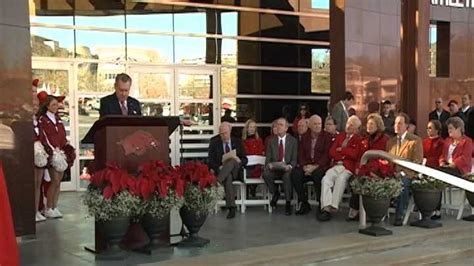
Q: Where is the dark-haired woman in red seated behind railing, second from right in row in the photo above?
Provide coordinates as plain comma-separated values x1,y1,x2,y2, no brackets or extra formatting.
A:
423,120,444,168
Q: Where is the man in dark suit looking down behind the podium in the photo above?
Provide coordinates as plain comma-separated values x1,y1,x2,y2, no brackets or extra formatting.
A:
99,73,142,117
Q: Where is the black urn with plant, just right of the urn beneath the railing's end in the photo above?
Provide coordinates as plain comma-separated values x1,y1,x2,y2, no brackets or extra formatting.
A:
410,176,447,228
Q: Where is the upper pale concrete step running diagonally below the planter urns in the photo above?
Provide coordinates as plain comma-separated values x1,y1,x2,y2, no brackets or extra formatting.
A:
145,221,474,265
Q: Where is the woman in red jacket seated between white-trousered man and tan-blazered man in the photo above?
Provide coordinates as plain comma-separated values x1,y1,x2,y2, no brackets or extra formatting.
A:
346,113,388,221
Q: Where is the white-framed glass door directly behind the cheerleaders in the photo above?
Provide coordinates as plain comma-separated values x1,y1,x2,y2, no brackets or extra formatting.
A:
32,60,79,191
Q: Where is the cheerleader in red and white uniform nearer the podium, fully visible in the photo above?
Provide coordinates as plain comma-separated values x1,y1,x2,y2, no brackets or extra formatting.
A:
37,95,68,218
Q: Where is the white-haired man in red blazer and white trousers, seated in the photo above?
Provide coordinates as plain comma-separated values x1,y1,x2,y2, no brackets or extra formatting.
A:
317,115,362,221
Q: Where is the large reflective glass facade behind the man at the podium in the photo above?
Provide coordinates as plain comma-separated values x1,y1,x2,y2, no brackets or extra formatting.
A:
30,0,330,191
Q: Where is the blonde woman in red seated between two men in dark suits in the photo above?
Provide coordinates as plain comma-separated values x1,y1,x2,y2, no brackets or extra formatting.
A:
242,119,265,197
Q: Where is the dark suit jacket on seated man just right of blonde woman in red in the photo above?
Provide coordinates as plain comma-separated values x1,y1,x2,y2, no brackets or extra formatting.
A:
265,134,298,168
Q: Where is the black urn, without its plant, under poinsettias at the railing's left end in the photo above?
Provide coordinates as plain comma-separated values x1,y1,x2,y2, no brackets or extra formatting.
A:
359,196,392,236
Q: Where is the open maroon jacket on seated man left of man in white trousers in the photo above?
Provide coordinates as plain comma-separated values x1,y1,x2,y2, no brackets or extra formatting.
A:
298,131,332,170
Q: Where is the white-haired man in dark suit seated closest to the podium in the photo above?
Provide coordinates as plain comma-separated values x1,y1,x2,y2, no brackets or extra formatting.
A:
209,122,247,219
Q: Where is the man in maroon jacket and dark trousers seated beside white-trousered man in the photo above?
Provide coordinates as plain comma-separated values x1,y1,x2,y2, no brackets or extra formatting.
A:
291,115,332,215
